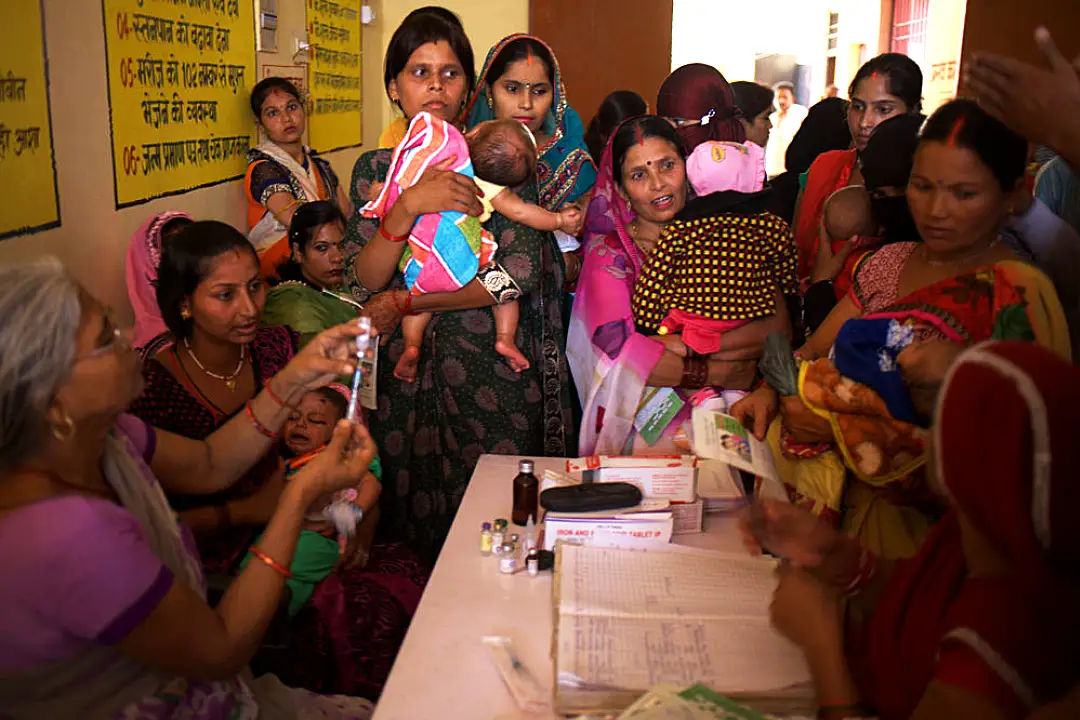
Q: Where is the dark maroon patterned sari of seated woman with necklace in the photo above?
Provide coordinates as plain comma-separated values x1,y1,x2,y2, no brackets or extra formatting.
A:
132,327,428,699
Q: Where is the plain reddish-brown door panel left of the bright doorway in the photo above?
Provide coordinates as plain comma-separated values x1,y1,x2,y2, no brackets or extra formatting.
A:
529,0,672,142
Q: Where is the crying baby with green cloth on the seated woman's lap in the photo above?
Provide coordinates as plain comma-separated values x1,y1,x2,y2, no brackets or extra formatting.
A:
241,384,381,616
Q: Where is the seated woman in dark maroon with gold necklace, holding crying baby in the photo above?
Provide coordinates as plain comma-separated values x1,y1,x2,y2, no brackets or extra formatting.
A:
132,222,427,698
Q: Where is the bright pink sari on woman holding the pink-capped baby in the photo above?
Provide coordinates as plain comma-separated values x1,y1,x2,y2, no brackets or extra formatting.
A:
566,142,664,456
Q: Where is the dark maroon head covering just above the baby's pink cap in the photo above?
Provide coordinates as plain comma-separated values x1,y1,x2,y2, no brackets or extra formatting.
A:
657,63,746,153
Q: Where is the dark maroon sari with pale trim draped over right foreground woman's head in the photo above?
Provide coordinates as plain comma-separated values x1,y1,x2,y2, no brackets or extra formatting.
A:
847,342,1080,720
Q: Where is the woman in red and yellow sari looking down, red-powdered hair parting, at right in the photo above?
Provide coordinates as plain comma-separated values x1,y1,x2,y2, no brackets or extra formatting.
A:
732,100,1069,558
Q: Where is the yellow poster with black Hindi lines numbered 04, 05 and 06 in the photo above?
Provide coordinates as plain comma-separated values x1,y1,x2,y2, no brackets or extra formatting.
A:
102,0,258,207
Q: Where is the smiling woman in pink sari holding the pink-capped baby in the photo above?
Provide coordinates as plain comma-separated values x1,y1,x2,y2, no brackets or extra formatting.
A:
567,116,786,454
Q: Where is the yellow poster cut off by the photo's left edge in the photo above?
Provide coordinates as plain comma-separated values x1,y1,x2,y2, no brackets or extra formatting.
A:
0,0,60,237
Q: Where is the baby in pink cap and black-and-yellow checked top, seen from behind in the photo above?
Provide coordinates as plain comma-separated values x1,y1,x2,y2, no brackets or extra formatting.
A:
632,141,798,355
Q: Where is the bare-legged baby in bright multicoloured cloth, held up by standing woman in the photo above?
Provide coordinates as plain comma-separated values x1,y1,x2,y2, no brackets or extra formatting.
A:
361,112,582,382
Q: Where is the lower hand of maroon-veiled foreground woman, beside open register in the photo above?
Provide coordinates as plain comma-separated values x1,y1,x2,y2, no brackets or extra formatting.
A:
769,565,843,655
